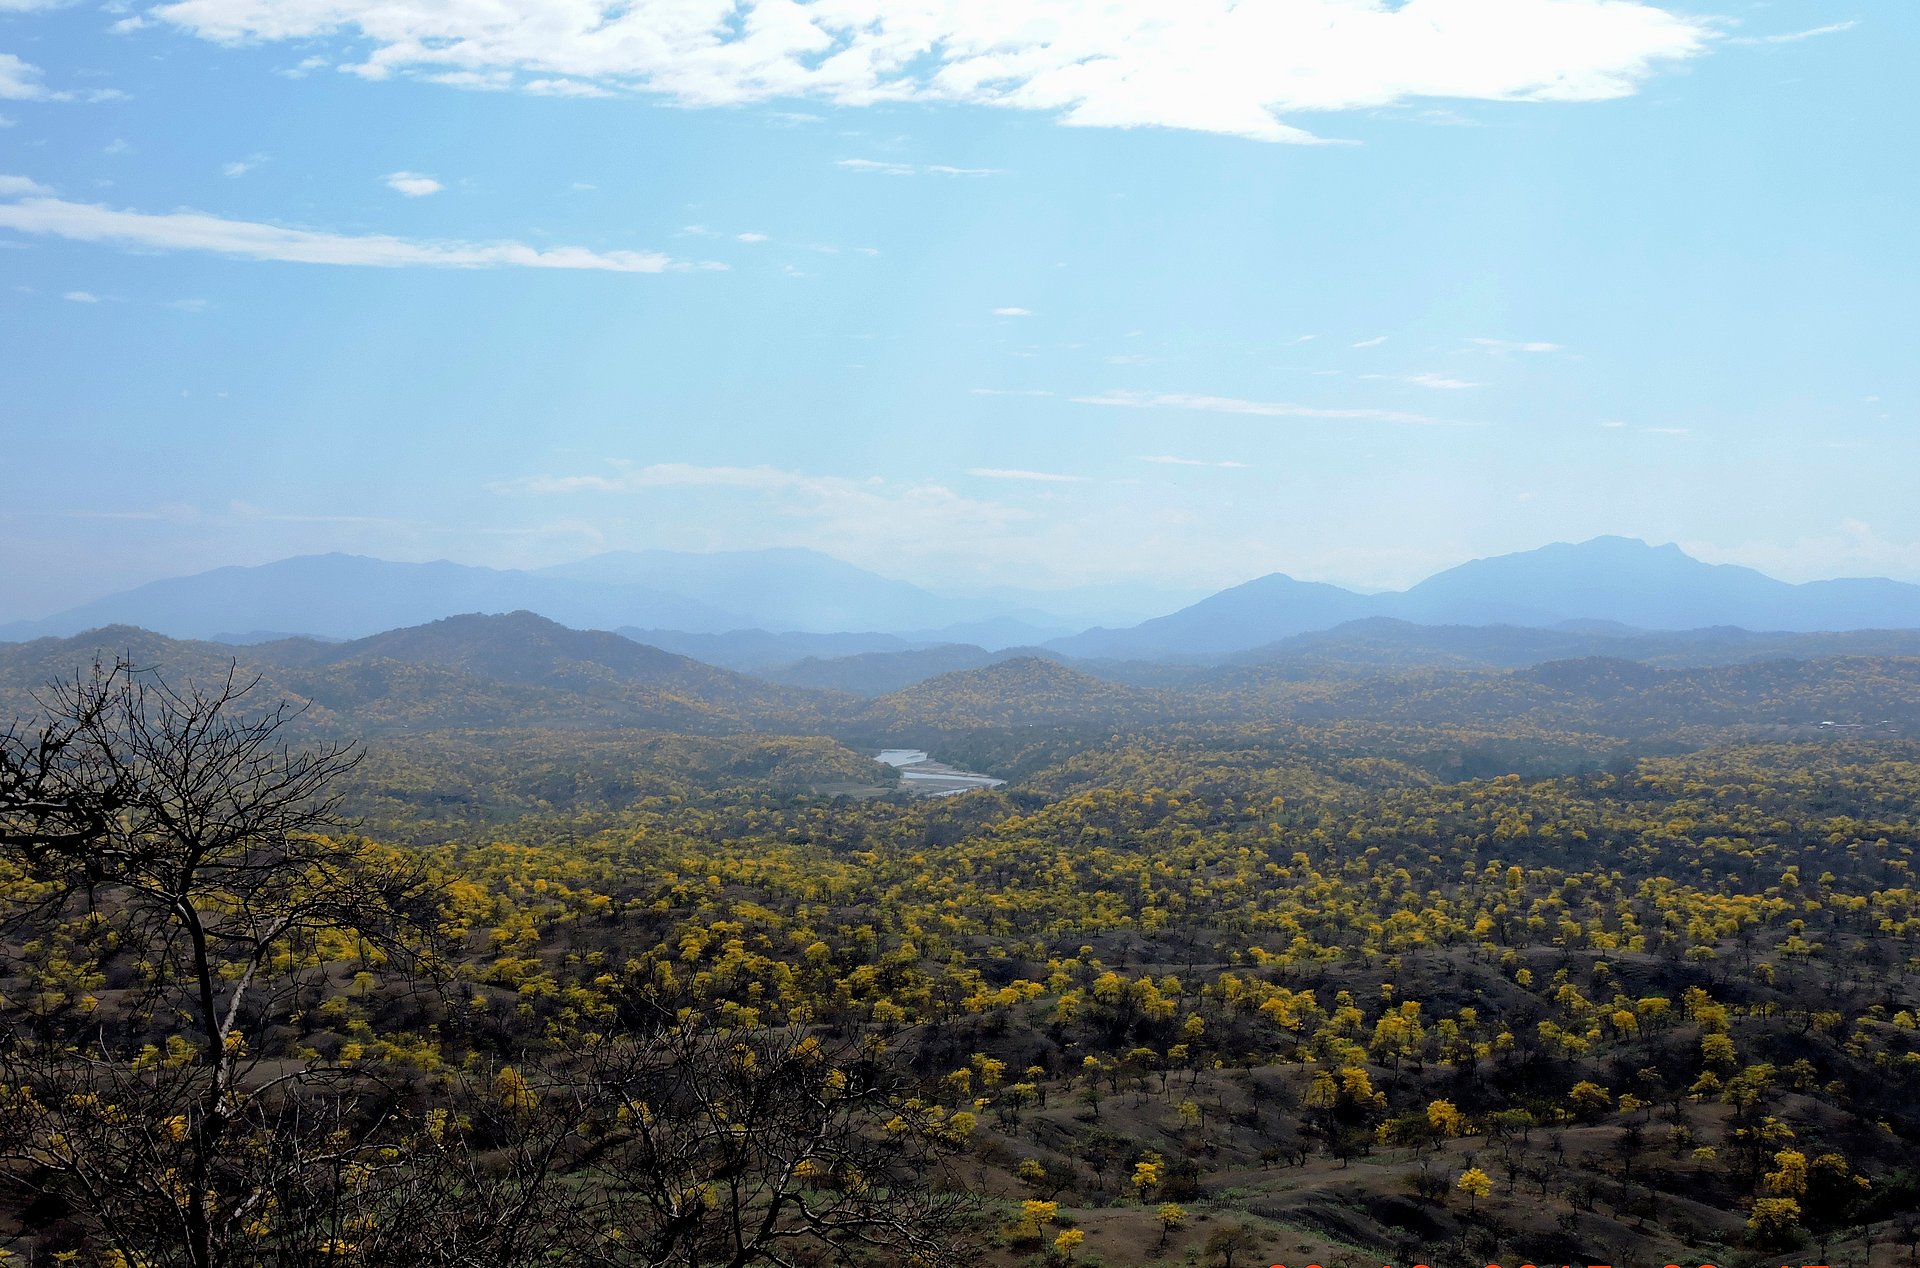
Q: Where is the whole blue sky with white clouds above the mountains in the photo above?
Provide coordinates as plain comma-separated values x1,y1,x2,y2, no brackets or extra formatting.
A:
0,0,1920,621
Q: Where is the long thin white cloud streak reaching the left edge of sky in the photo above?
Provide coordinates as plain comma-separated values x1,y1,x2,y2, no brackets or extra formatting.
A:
0,198,687,273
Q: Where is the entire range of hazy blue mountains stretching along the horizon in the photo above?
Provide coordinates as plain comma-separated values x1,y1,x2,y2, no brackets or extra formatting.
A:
0,538,1920,657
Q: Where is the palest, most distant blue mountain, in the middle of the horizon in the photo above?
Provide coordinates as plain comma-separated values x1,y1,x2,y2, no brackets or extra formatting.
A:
540,549,1073,634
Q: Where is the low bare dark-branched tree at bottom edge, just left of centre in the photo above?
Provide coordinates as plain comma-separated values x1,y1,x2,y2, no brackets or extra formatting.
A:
586,1018,972,1268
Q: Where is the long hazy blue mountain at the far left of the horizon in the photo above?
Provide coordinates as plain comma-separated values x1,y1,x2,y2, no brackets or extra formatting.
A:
0,555,755,642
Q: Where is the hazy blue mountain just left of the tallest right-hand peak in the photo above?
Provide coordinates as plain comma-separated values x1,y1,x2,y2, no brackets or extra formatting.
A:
1044,573,1379,659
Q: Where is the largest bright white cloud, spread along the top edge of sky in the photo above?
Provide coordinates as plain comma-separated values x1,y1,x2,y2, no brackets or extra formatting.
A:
152,0,1713,142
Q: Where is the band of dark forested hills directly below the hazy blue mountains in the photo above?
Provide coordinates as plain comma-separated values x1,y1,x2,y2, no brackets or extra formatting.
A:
0,613,1920,747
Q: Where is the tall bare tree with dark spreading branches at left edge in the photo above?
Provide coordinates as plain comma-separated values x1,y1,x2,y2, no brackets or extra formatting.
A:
0,661,440,1268
